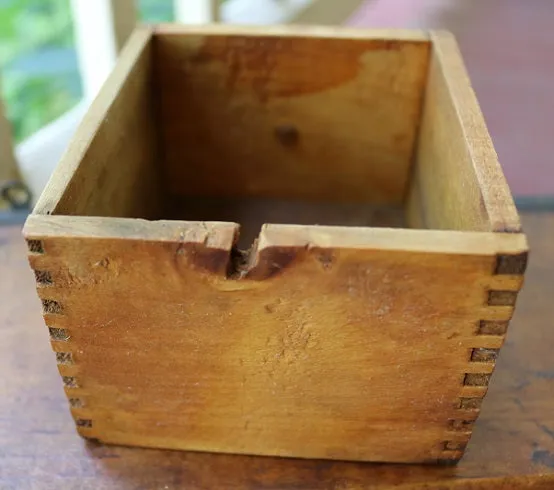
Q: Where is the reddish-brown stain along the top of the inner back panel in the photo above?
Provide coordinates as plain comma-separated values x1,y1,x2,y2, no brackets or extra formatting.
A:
189,36,412,103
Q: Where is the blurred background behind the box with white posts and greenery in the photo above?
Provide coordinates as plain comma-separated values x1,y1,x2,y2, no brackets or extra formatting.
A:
0,0,554,211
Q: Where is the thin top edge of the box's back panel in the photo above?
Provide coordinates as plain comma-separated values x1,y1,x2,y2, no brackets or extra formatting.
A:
153,23,430,43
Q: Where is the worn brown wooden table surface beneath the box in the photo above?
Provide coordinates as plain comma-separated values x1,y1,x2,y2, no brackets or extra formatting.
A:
0,213,554,490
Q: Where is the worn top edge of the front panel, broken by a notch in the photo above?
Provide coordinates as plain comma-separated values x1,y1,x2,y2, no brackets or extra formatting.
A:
23,214,528,258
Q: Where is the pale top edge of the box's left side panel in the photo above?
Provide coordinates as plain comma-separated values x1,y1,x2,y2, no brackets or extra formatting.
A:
33,26,152,215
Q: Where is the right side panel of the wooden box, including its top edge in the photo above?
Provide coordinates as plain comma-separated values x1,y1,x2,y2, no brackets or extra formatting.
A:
407,32,521,232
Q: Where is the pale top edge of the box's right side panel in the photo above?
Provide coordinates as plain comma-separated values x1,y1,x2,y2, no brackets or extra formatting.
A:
430,31,521,233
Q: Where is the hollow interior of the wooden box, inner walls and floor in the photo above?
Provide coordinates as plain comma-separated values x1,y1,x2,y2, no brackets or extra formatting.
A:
40,27,516,247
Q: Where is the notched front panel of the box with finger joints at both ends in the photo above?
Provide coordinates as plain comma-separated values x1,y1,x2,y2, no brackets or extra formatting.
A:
22,217,526,462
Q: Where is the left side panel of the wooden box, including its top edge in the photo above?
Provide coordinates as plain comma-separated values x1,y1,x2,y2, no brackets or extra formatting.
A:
34,28,161,218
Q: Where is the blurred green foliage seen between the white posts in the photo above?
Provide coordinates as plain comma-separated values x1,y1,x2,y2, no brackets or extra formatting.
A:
0,0,173,142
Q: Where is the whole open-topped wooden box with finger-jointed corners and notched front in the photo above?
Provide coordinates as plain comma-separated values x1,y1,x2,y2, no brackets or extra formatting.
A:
24,26,527,462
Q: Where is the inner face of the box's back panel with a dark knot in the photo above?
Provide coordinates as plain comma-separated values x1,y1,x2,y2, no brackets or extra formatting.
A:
154,28,429,203
